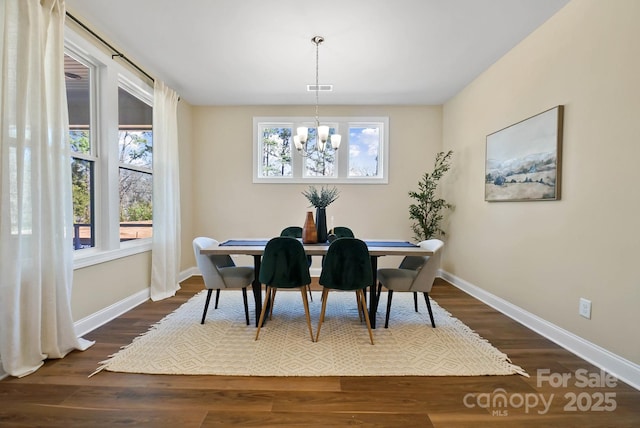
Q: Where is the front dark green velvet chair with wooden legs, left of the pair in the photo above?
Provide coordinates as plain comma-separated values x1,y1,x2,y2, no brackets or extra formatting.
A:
256,236,314,342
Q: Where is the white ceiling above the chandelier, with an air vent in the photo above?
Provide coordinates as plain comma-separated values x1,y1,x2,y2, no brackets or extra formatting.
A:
66,0,569,105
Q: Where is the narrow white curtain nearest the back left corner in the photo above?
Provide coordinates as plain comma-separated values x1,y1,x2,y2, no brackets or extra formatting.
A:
151,79,180,300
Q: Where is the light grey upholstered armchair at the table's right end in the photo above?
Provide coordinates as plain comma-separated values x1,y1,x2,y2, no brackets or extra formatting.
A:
377,239,444,328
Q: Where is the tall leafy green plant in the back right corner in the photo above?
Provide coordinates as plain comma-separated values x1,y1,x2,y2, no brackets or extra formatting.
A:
409,150,453,242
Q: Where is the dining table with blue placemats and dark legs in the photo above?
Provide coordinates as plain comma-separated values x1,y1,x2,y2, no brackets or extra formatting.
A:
200,238,433,328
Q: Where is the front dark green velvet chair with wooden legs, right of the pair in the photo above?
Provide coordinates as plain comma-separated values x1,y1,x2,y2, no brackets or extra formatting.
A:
316,238,373,345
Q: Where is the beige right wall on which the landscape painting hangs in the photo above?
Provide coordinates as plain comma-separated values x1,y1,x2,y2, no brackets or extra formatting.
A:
443,0,640,363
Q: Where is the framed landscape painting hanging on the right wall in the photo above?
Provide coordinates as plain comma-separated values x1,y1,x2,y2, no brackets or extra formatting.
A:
484,105,564,202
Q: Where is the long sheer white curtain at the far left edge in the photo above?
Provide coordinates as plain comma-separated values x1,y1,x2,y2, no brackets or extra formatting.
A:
0,0,92,377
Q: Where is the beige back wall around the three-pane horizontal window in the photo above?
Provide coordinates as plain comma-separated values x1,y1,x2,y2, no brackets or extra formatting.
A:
190,106,442,270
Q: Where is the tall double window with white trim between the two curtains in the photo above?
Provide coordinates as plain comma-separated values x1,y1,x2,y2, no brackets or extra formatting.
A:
65,28,153,268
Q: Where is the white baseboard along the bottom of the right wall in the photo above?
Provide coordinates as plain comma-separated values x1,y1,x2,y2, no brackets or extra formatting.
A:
440,270,640,390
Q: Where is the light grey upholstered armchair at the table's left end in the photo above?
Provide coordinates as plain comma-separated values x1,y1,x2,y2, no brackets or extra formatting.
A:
193,236,255,325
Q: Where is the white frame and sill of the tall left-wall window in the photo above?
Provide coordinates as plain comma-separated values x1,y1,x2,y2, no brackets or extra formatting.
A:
64,24,153,269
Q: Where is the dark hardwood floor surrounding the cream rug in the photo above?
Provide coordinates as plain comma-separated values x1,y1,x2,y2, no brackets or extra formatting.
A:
0,278,640,427
